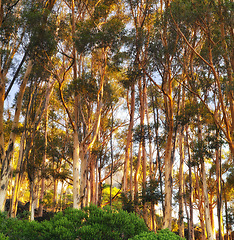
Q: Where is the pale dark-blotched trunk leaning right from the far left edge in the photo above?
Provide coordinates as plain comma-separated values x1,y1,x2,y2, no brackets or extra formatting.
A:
0,60,33,211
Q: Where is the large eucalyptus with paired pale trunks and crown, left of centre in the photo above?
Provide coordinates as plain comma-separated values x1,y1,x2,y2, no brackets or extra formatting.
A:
53,1,124,208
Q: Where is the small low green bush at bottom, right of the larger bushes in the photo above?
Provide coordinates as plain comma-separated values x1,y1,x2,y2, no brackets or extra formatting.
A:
129,229,186,240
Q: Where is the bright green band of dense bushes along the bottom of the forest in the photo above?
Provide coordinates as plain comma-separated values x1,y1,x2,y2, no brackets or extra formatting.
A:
0,206,185,240
